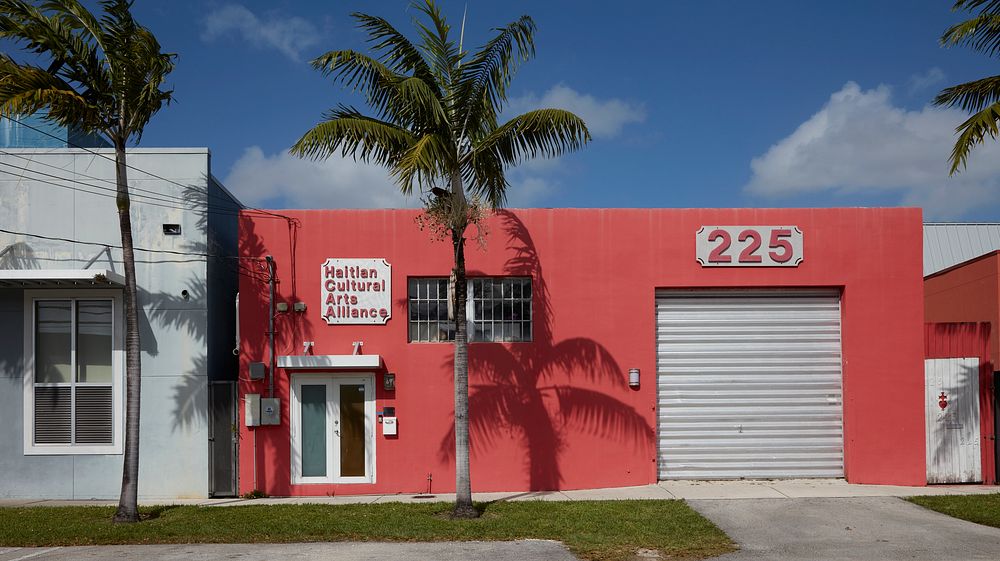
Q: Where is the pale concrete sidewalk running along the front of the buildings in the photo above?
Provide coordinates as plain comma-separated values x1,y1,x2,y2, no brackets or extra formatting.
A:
0,479,1000,507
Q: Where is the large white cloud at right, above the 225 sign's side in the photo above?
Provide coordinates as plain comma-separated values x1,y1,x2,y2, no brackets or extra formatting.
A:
744,82,1000,218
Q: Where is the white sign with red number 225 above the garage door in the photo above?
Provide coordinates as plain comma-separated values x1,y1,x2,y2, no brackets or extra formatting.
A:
695,226,802,267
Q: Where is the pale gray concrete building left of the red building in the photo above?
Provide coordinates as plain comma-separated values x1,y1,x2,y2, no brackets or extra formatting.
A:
0,117,240,499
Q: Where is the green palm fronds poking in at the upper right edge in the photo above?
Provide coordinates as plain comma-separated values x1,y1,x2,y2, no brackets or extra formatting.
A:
934,0,1000,175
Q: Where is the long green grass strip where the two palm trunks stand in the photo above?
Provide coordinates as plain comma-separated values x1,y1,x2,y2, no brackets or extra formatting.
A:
0,501,735,561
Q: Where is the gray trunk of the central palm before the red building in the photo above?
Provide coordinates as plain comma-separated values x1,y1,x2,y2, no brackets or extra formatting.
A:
451,174,479,518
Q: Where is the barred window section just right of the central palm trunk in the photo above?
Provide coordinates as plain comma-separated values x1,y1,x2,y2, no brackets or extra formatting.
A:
469,277,531,341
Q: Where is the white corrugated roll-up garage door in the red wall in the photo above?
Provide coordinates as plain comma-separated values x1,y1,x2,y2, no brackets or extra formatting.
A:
656,290,844,479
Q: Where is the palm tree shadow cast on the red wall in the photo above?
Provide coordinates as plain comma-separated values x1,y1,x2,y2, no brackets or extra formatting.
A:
439,211,653,491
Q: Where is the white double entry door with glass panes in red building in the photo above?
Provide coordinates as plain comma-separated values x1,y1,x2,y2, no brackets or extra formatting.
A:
291,375,375,483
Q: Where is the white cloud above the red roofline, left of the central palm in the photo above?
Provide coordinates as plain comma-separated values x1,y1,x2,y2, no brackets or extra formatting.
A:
223,146,420,208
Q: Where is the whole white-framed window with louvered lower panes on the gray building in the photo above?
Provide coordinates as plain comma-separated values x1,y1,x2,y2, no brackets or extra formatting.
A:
24,290,125,455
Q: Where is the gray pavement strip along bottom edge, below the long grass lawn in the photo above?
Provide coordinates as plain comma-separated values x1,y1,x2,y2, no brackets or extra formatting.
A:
0,540,578,561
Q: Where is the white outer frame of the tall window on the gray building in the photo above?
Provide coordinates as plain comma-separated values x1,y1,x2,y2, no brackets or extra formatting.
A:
22,289,125,456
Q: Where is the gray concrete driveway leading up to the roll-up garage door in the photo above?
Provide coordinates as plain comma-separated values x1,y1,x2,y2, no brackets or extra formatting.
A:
688,497,1000,561
